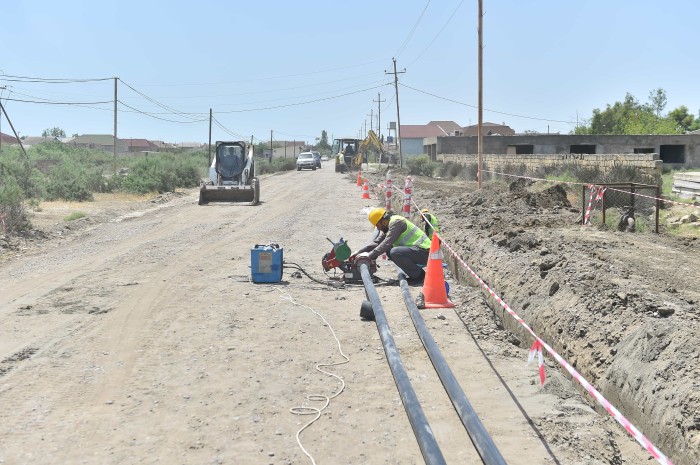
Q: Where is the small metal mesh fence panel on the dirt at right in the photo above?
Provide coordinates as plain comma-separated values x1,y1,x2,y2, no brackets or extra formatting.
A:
581,183,661,234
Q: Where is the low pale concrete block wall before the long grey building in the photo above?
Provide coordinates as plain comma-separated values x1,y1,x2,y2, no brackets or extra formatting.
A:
436,153,663,177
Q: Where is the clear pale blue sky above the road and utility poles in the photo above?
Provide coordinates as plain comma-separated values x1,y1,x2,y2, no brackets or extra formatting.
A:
0,0,700,142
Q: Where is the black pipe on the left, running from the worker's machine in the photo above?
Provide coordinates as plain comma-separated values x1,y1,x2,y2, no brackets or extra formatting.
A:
359,262,447,465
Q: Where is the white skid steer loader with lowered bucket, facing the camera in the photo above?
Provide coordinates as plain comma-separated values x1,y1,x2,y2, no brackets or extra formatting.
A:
199,141,260,205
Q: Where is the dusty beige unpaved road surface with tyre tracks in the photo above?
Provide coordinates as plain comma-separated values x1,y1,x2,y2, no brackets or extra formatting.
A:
0,165,680,465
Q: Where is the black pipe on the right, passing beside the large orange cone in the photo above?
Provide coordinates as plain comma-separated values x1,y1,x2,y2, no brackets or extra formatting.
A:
399,273,506,465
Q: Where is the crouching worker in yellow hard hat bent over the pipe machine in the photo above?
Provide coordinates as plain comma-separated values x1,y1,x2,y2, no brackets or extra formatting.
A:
350,208,430,285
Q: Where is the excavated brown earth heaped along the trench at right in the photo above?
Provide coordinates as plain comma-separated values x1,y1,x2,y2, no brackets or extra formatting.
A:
372,170,700,465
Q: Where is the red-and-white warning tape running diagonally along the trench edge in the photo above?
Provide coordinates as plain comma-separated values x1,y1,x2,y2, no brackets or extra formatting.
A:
404,190,673,465
